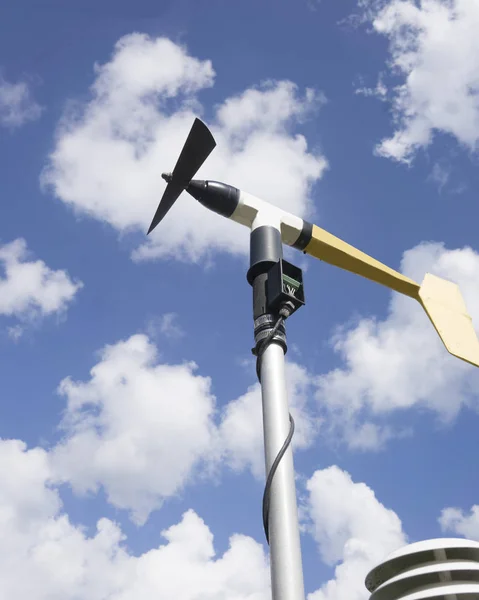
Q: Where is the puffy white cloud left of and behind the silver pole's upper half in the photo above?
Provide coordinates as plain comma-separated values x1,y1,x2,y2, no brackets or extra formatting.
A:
51,335,318,524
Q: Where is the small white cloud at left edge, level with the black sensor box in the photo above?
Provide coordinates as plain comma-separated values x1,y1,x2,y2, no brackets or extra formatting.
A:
0,238,83,326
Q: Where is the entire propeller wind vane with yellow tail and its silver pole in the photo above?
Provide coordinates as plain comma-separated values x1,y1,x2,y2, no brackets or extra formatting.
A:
148,119,479,600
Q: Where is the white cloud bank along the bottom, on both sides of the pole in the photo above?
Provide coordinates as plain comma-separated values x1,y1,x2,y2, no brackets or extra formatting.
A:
0,440,414,600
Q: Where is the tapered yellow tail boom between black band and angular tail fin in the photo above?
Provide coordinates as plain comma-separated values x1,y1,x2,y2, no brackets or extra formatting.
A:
304,225,419,300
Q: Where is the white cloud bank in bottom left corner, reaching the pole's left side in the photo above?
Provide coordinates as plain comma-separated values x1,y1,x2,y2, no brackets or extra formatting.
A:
0,440,270,600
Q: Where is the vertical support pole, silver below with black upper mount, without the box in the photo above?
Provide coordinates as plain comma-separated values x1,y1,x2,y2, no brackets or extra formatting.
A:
248,225,304,600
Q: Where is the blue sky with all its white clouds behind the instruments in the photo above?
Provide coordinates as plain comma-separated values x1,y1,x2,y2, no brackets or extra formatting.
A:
0,0,479,600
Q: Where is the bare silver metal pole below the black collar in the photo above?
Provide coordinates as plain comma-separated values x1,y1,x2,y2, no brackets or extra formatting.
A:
261,343,304,600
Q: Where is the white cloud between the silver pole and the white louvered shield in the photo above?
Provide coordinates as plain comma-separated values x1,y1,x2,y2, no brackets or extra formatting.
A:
306,466,407,600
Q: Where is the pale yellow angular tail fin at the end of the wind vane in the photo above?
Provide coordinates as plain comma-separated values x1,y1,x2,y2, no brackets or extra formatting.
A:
419,273,479,367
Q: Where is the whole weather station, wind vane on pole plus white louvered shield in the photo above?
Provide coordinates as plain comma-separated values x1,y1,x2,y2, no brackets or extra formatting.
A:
148,119,479,600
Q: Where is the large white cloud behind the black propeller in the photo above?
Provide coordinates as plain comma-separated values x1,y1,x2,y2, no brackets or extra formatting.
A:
42,34,326,261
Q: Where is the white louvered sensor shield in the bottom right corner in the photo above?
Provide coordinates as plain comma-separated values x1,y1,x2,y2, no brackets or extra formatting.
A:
366,538,479,600
